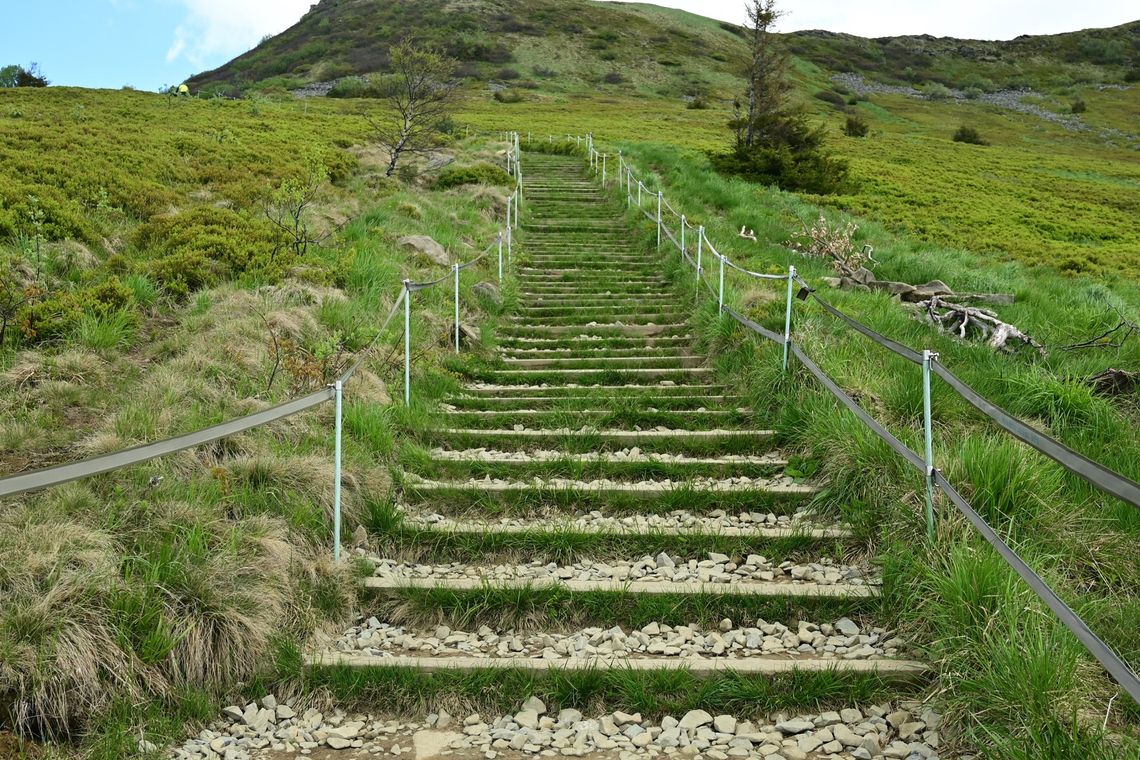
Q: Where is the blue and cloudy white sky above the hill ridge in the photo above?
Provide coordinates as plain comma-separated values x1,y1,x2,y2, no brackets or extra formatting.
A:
0,0,1140,90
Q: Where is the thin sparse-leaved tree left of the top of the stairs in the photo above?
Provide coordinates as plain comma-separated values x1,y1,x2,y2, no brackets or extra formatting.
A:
372,41,459,177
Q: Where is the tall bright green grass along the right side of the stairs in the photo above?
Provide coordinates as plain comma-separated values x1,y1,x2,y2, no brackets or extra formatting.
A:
622,145,1140,758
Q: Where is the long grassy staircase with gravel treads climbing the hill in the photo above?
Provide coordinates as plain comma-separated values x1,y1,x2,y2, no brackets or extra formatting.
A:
308,154,937,760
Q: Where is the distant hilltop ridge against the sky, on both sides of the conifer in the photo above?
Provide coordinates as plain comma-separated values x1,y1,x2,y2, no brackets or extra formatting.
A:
190,0,1140,97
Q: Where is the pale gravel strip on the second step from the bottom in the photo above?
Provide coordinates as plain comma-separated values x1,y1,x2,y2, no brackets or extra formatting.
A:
369,551,881,586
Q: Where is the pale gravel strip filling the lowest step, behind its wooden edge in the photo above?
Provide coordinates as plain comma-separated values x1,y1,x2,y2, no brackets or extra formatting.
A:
333,618,903,660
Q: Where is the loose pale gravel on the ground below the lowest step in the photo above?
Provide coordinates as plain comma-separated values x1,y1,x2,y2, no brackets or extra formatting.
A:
168,696,953,760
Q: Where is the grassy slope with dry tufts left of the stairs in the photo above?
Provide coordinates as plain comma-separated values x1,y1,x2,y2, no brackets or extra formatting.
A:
0,90,513,760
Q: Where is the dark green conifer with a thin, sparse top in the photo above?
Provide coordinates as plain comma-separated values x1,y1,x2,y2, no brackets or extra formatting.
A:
713,0,848,193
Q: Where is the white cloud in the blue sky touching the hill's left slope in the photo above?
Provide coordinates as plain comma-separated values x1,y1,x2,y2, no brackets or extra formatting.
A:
166,0,315,66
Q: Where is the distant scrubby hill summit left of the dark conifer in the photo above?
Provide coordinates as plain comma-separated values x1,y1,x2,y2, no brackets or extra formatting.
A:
189,0,743,96
